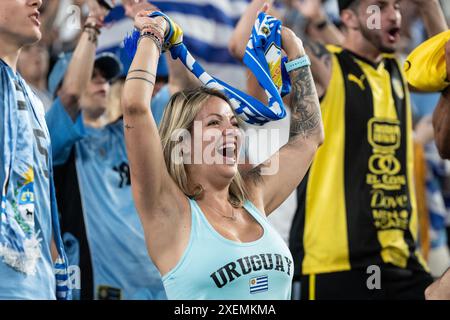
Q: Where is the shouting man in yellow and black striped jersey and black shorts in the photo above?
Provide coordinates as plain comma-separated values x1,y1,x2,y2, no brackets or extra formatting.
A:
290,0,447,300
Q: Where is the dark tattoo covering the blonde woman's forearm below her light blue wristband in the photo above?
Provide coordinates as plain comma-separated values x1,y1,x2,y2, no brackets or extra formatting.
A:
289,63,322,142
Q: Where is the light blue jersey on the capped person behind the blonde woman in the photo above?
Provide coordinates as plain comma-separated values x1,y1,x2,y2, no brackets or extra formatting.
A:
47,99,166,299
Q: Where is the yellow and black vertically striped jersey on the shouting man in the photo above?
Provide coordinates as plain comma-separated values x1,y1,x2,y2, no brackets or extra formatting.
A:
290,46,425,276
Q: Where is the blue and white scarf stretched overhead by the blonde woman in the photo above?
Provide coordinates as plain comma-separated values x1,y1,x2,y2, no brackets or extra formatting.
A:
124,12,290,125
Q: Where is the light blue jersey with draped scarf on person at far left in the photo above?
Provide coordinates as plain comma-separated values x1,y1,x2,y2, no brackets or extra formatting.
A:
0,60,56,300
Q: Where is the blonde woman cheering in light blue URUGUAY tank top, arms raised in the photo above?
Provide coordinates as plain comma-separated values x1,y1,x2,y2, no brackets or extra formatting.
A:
122,12,323,299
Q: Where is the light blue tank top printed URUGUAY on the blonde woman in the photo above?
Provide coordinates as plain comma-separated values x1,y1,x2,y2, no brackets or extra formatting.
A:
163,200,294,300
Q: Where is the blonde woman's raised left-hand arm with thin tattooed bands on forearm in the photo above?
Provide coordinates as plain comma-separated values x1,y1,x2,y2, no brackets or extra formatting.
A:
121,11,190,274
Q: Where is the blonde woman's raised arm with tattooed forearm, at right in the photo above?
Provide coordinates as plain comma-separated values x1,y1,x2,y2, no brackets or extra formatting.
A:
244,28,324,215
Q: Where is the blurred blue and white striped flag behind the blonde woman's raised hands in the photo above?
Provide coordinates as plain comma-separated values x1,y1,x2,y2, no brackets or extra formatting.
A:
98,0,255,88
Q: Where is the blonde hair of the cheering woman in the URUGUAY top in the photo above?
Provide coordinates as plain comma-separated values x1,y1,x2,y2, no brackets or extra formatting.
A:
159,87,247,207
